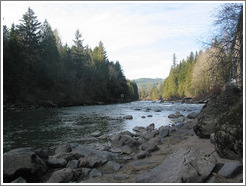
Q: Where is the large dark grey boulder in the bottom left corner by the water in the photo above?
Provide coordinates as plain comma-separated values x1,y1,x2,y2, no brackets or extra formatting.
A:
3,148,47,182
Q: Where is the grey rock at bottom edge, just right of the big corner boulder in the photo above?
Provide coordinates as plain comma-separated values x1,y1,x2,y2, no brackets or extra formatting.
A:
47,168,73,183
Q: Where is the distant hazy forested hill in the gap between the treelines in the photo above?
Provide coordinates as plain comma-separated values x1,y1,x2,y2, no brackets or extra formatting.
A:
134,78,164,91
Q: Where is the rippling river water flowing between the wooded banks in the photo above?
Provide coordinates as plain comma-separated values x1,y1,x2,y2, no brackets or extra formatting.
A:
3,101,203,152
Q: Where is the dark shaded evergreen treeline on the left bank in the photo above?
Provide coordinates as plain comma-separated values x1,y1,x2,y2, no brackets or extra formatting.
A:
3,8,138,106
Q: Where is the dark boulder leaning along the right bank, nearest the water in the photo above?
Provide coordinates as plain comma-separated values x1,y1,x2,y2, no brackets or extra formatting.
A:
194,86,241,138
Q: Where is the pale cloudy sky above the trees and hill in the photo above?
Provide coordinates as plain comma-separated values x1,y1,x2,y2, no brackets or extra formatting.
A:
1,1,223,79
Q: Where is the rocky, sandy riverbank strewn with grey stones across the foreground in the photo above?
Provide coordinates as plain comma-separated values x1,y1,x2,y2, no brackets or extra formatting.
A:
3,107,243,183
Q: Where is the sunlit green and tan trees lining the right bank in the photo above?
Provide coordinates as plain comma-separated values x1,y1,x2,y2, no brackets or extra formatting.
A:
151,4,243,99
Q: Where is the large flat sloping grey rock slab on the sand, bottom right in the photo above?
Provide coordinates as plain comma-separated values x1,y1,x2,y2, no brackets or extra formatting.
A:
136,148,216,183
